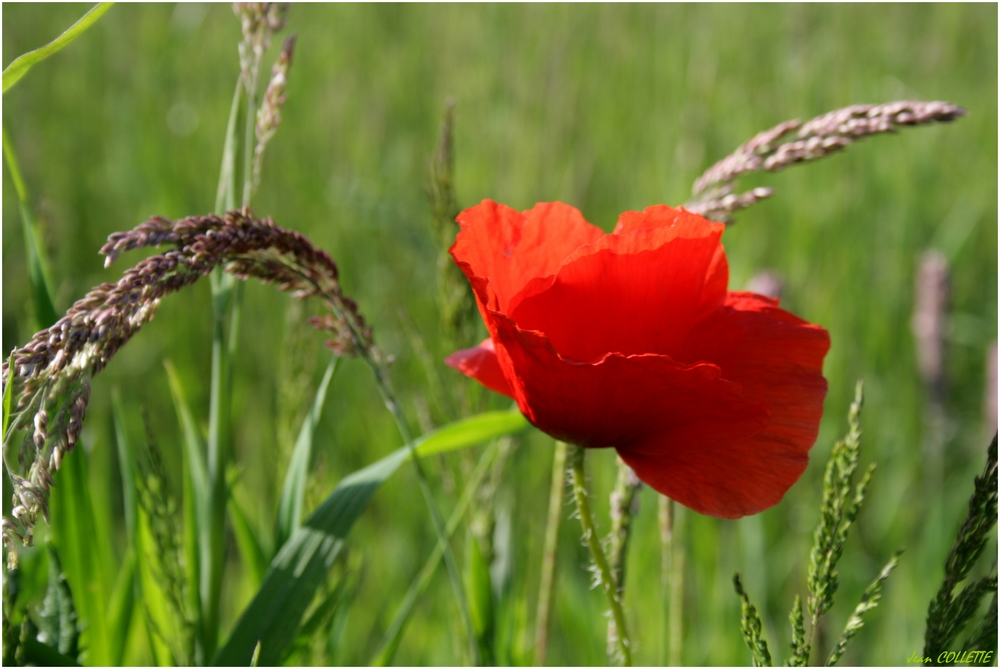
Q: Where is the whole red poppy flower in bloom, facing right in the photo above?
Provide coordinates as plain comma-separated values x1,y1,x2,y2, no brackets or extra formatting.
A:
446,200,830,518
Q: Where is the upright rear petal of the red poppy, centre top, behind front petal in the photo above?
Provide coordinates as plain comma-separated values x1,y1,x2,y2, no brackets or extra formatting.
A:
506,218,729,362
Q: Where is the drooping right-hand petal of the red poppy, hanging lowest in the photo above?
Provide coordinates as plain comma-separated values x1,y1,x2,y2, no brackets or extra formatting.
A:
619,293,830,518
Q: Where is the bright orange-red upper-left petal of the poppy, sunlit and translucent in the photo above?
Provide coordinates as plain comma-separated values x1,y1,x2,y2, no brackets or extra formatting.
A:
450,200,604,315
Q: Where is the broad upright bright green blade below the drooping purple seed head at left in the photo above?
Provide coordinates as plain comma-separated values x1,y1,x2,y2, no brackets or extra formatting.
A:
50,448,115,666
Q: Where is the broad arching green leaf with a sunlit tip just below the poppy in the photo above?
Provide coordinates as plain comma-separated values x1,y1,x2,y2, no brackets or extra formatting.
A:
212,411,528,666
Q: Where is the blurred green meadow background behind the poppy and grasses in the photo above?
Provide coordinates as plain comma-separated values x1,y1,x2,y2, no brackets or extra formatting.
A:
2,3,997,664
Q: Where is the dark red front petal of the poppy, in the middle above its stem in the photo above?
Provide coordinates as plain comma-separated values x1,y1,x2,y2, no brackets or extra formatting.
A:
493,314,768,449
